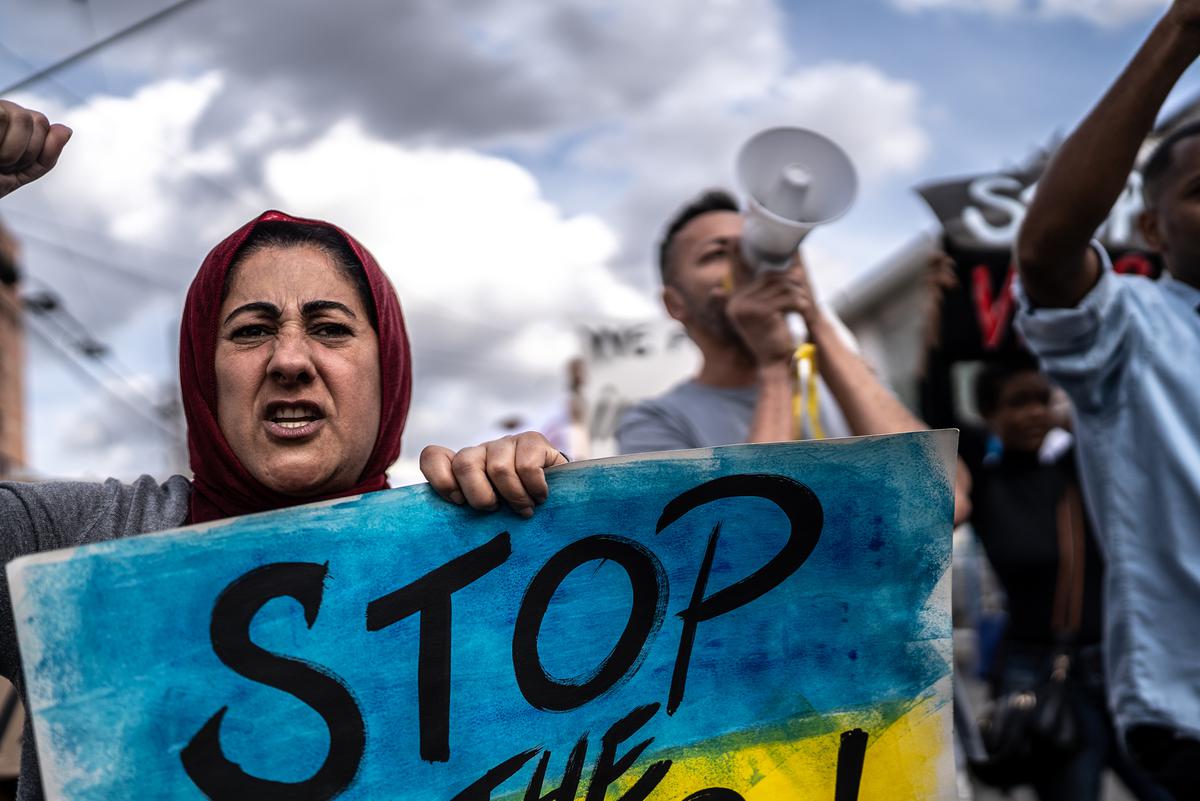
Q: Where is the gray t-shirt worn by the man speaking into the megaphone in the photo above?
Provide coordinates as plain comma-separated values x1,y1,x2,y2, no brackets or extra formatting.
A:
617,380,851,453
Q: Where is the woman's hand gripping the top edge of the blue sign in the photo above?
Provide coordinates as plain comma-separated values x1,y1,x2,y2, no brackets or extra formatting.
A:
421,432,568,518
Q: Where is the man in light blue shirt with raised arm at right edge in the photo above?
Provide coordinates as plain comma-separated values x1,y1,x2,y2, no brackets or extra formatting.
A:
1018,0,1200,799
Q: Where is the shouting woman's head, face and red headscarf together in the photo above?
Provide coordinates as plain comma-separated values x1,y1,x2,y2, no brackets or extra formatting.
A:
180,211,413,523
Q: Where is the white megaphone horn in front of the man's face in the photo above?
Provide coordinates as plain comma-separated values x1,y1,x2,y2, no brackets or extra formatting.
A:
736,127,858,270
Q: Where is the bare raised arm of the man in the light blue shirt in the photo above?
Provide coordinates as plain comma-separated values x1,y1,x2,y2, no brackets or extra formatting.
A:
1016,0,1200,307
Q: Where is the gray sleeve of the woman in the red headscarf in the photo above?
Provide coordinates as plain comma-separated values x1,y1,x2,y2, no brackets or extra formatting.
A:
0,476,192,801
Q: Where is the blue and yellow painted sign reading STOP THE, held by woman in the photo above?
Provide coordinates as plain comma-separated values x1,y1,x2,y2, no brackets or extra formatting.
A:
7,432,955,801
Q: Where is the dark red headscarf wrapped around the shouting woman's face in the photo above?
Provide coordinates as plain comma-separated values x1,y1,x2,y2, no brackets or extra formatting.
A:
179,211,413,523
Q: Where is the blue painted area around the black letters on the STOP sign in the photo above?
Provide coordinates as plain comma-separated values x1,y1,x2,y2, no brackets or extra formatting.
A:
8,433,953,801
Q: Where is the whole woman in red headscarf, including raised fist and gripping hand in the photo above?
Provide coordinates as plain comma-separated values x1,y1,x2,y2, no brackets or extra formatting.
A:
0,101,565,801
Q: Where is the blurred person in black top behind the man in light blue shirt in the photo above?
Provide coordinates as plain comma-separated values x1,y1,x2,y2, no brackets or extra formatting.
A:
970,357,1166,801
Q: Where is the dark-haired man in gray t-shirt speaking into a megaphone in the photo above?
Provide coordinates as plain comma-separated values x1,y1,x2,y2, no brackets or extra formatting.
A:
617,189,968,522
